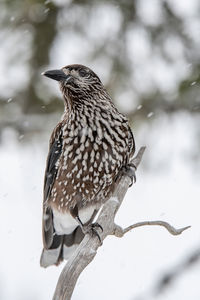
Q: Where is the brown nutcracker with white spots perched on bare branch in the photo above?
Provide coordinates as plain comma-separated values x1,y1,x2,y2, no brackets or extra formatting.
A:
40,64,135,267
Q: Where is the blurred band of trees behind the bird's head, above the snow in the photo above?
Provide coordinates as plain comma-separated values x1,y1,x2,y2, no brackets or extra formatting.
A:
0,0,200,131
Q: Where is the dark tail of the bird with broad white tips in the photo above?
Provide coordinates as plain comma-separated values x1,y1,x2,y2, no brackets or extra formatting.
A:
40,226,84,268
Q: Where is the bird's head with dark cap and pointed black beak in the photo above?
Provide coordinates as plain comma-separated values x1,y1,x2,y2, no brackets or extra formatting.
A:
42,64,103,95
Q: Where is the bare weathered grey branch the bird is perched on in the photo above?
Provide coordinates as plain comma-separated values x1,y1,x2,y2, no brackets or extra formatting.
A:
53,147,189,300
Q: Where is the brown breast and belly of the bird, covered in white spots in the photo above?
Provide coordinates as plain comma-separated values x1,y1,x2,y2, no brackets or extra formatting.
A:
51,114,128,211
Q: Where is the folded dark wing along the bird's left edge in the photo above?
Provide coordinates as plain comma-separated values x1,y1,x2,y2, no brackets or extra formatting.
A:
42,123,63,249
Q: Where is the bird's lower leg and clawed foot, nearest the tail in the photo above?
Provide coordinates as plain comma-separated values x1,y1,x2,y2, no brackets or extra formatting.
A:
70,205,103,245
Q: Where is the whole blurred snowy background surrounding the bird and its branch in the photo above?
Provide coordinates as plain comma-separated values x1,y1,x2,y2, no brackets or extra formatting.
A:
0,0,200,300
